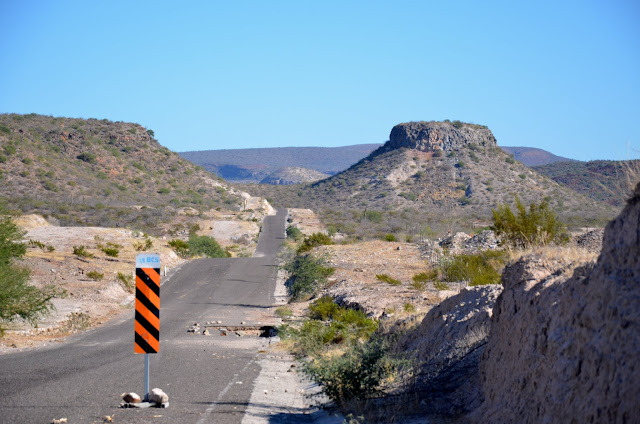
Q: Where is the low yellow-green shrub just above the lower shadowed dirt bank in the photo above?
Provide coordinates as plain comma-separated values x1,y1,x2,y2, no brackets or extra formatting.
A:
442,250,508,286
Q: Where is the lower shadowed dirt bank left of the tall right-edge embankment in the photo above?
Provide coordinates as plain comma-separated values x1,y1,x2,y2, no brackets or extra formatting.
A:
395,285,502,417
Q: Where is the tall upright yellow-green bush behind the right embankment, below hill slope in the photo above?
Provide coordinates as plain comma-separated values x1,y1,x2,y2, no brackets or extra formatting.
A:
492,196,569,248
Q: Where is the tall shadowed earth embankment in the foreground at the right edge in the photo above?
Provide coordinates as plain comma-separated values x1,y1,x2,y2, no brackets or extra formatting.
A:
469,185,640,423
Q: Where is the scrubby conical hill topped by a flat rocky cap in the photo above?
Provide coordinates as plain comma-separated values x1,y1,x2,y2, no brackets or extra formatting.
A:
252,121,615,230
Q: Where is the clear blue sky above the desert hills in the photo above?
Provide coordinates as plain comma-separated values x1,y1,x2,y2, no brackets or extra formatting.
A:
0,0,640,160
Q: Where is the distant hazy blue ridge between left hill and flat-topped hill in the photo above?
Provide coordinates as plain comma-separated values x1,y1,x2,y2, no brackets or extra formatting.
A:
178,144,380,182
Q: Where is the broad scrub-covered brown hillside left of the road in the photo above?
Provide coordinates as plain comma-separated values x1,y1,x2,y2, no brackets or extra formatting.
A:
0,114,242,229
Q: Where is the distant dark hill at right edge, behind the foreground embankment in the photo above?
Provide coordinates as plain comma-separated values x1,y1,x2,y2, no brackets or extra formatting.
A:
533,160,640,207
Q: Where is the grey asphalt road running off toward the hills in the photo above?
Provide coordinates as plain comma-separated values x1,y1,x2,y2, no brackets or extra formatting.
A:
0,211,286,424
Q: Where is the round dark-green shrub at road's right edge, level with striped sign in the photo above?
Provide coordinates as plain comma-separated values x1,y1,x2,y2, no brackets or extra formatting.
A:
284,254,335,301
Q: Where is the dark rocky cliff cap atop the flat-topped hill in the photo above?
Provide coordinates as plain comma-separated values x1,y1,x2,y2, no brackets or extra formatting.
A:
387,121,498,152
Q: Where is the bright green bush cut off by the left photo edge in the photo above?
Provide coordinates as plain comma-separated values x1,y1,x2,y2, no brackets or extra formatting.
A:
0,210,64,336
